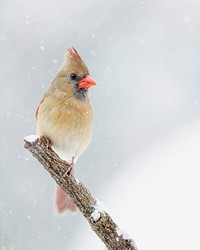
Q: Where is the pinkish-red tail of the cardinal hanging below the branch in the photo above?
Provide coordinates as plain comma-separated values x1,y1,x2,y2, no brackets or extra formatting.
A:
53,185,77,214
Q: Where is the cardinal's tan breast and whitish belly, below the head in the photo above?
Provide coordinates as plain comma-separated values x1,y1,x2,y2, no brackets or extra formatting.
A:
37,94,93,163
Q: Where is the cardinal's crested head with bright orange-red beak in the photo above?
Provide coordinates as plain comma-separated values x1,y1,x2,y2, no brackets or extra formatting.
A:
54,47,96,99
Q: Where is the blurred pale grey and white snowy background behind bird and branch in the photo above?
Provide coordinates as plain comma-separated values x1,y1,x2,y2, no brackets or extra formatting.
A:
0,0,200,250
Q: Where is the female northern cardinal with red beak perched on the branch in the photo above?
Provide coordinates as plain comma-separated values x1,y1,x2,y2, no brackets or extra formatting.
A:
36,48,96,213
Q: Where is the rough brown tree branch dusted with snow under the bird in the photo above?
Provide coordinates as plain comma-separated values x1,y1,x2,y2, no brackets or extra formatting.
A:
24,137,137,250
